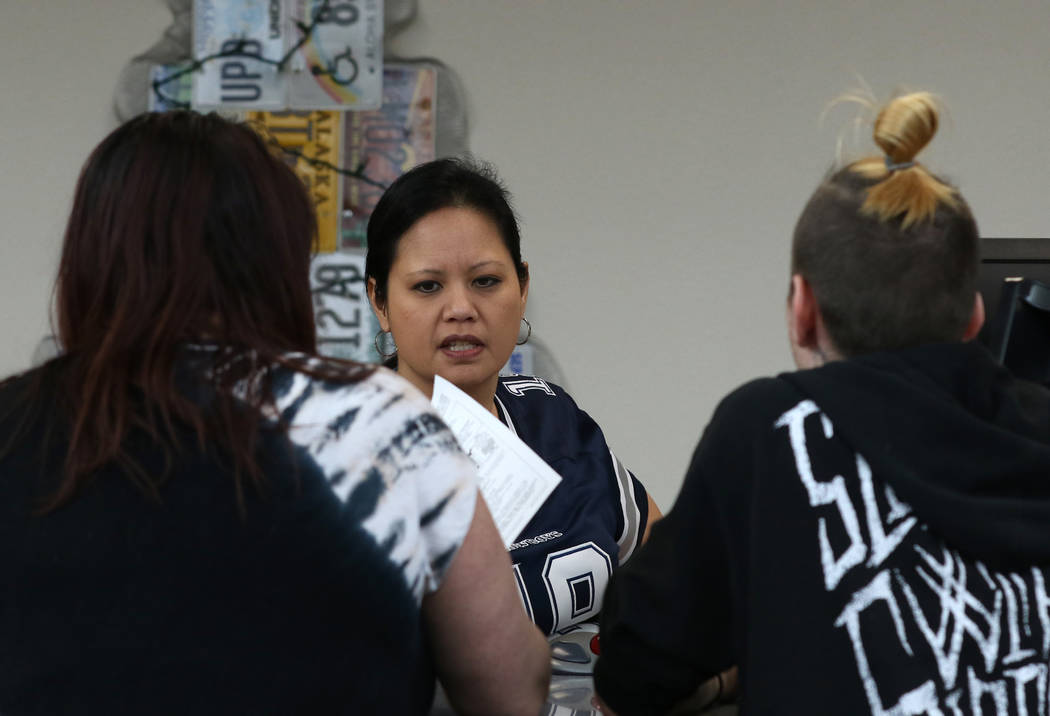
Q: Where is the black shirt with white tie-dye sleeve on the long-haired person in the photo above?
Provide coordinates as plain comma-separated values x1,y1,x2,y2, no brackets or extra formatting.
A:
0,346,477,714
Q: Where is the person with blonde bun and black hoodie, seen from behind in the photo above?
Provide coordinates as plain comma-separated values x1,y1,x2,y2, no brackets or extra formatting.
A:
594,92,1050,715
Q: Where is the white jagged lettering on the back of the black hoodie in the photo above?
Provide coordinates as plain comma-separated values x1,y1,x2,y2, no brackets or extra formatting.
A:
774,400,1050,716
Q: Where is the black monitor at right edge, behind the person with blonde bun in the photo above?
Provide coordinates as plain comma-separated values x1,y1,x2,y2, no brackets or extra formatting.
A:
978,238,1050,384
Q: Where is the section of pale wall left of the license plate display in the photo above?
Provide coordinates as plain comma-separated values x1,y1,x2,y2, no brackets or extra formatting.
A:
0,0,171,367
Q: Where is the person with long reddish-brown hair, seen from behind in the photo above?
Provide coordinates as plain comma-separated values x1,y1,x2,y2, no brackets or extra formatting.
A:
0,111,549,714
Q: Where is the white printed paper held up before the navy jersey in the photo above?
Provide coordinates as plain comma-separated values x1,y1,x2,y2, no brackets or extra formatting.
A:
431,376,562,547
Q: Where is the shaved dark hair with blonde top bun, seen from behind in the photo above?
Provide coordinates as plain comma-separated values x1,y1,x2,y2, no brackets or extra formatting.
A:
792,92,979,356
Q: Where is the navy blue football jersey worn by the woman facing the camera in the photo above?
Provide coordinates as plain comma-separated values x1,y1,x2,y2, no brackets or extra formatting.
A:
496,376,649,634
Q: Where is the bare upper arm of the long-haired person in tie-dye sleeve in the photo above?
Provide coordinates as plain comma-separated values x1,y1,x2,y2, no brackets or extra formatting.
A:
423,494,550,716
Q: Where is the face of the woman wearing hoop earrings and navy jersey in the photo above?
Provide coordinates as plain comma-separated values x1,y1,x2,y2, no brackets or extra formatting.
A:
369,208,528,409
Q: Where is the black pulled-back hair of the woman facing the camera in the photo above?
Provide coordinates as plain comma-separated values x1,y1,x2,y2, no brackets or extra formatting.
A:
364,157,528,304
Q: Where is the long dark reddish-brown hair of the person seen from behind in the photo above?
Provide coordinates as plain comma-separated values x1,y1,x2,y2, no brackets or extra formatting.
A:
4,111,370,510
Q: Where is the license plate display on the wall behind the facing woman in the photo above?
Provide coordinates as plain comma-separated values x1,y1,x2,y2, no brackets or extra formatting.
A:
116,0,466,361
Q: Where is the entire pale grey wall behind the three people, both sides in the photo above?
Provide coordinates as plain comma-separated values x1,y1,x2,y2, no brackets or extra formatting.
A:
0,0,1050,508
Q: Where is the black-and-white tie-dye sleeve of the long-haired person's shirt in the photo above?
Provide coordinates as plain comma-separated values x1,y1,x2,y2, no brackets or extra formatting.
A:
275,356,477,603
